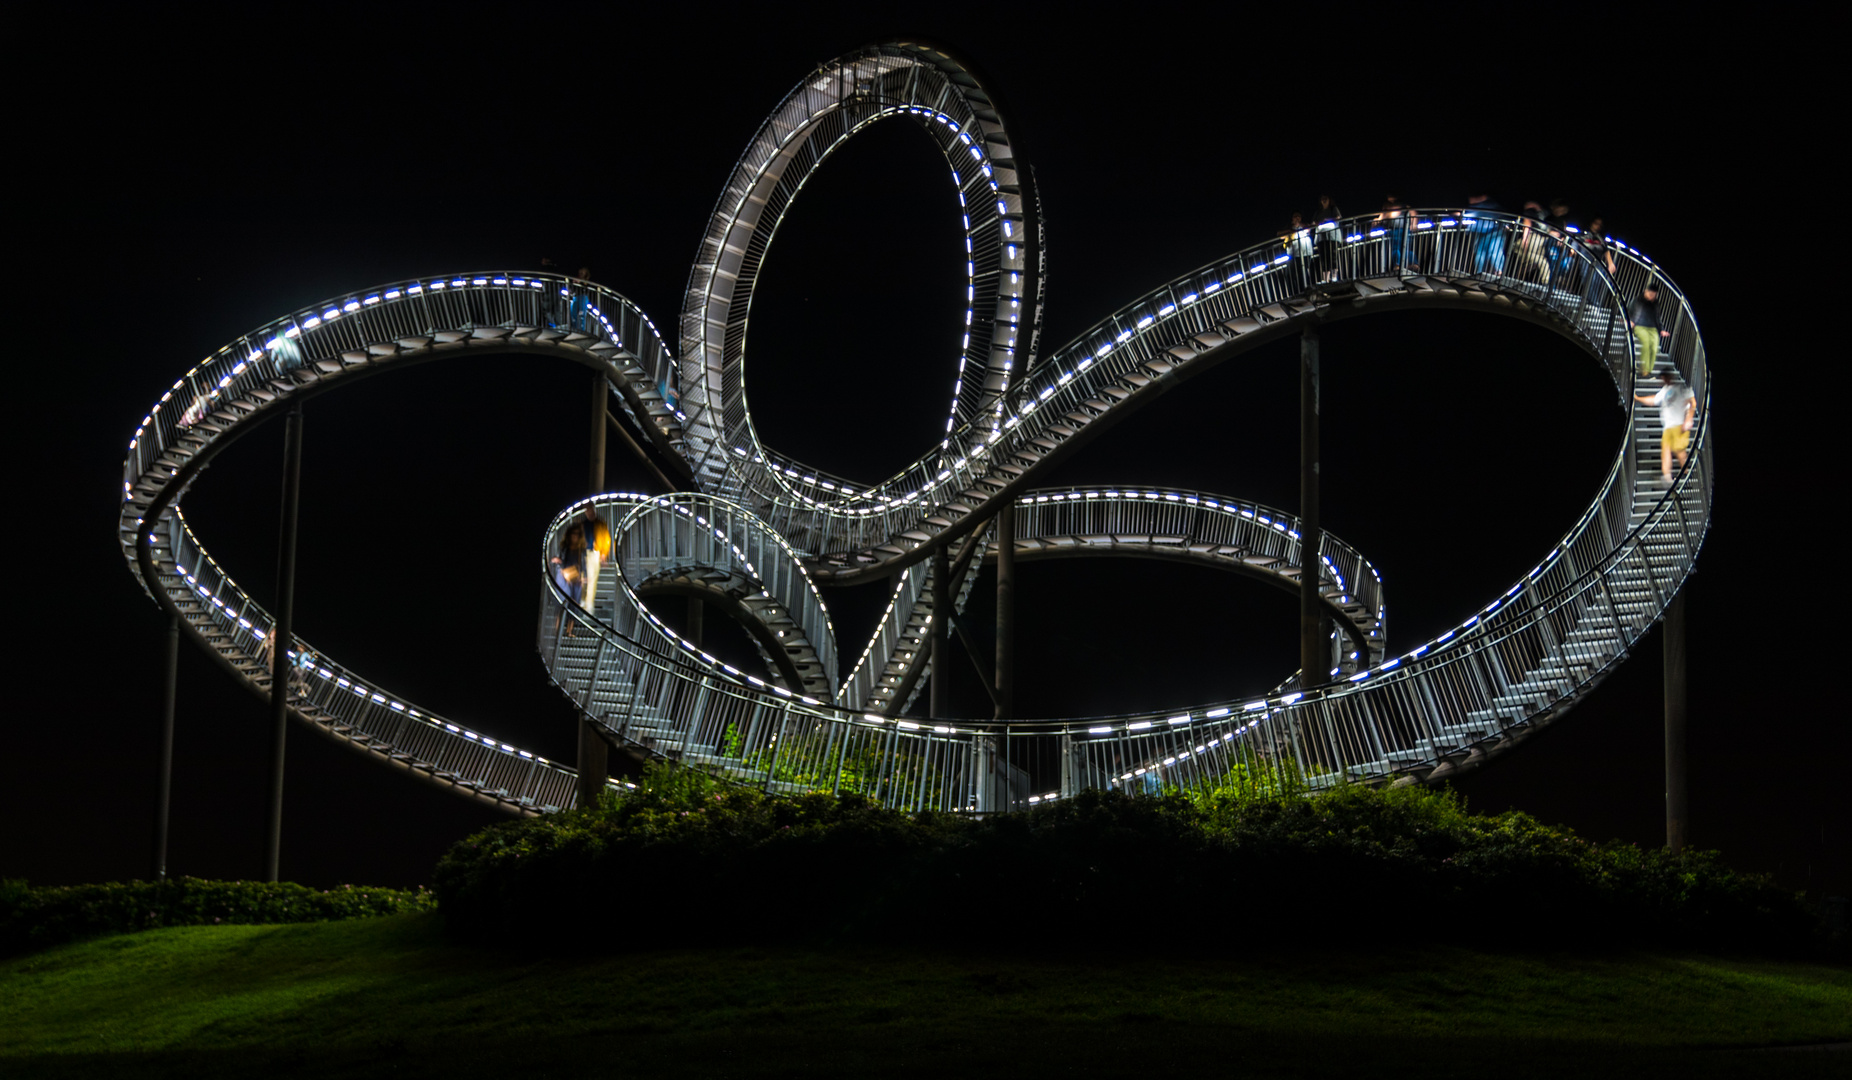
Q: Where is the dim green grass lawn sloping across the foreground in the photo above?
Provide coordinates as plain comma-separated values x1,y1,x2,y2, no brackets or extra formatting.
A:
0,915,1852,1080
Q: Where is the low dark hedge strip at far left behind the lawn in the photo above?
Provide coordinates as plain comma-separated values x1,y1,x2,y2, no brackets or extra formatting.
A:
0,878,435,956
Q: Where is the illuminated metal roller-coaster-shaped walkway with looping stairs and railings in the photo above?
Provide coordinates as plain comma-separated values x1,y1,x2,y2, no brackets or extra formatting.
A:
119,44,1711,813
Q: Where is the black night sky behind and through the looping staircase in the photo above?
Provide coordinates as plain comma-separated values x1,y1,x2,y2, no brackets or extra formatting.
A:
0,6,1852,895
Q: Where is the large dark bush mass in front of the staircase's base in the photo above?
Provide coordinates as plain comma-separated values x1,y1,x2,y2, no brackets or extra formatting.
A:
433,769,1819,952
